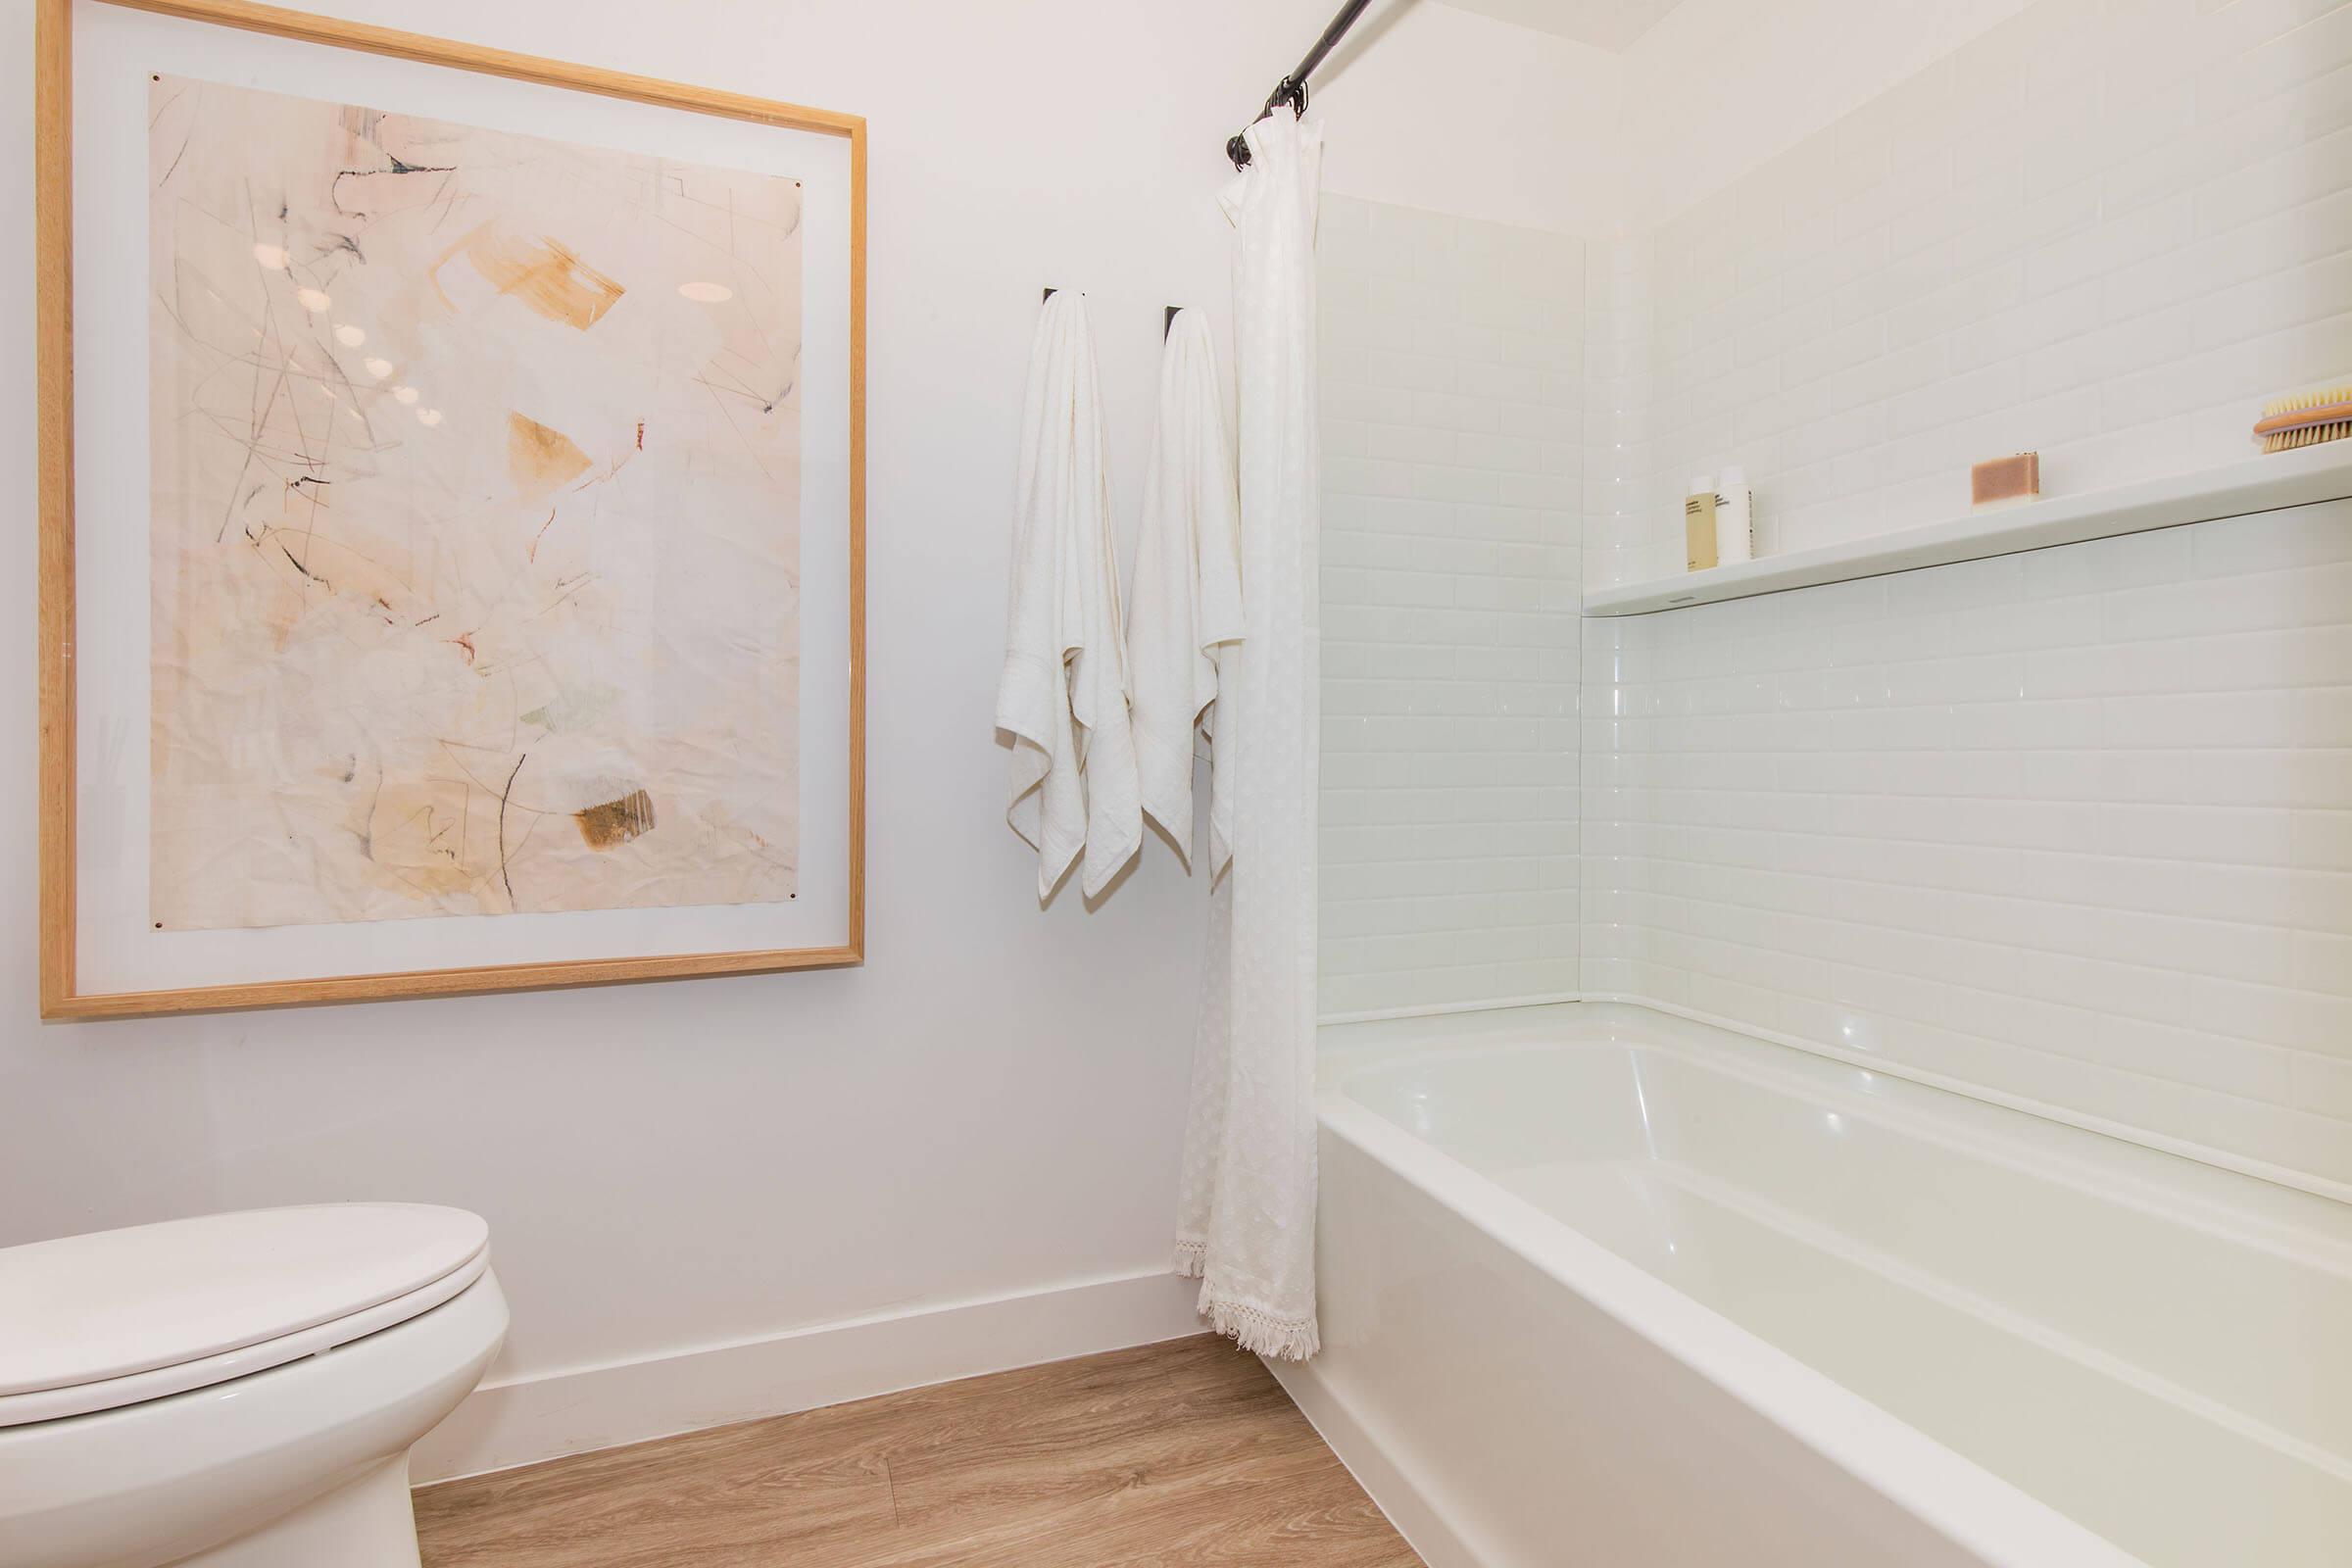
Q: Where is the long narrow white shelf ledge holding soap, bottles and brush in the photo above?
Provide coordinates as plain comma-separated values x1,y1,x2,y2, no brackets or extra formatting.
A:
1586,442,2352,615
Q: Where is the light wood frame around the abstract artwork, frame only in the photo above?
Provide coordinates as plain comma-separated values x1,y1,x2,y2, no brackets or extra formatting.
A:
35,0,865,1020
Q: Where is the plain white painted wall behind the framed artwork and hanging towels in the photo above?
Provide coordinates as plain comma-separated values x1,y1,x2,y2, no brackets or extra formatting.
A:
0,0,1599,1441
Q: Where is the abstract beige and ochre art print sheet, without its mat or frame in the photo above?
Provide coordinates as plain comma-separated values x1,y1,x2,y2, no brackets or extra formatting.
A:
148,75,802,931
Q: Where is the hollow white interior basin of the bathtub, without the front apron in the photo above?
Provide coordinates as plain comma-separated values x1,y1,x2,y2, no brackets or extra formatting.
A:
1341,1008,2352,1568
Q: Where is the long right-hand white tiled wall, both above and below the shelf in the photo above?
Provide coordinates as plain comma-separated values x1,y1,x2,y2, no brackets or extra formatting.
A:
1583,0,2352,1183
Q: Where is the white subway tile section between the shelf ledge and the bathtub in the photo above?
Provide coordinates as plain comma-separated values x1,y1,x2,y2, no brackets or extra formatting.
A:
1583,503,2352,1183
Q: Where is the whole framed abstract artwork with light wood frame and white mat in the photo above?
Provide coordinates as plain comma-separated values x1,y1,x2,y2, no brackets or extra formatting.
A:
37,0,865,1018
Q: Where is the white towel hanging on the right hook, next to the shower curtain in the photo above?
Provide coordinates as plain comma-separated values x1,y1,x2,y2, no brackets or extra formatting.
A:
1127,311,1242,877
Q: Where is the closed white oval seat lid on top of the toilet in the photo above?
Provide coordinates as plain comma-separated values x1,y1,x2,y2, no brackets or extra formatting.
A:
0,1203,489,1394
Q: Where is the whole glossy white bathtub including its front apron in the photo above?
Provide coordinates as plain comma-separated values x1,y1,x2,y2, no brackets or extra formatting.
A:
1277,1004,2352,1568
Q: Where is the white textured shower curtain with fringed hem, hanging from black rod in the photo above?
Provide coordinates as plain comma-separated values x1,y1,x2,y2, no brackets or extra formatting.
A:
1176,111,1322,1361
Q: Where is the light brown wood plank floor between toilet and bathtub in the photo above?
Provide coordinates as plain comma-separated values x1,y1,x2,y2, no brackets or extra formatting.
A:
416,1336,1421,1568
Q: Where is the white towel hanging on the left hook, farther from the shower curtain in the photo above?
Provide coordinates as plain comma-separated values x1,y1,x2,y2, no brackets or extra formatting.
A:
998,289,1143,898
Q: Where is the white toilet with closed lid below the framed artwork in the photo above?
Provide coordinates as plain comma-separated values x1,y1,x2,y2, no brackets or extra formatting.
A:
0,1203,506,1568
